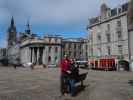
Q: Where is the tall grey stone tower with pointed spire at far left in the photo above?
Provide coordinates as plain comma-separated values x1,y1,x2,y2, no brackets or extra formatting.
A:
7,17,19,64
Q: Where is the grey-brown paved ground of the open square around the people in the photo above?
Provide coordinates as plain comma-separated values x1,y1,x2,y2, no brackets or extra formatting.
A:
0,67,133,100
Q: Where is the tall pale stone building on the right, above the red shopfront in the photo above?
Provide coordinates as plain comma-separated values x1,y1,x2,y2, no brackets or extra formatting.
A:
87,3,129,60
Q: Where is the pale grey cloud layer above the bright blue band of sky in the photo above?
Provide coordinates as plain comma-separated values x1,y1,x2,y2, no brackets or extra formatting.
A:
0,0,126,35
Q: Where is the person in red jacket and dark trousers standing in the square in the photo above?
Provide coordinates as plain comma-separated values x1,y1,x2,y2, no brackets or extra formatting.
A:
60,55,71,95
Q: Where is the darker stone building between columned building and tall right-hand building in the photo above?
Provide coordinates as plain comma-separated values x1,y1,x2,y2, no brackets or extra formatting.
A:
62,38,88,60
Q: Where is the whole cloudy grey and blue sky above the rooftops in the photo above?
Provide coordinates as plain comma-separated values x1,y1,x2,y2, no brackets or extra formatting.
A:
0,0,127,47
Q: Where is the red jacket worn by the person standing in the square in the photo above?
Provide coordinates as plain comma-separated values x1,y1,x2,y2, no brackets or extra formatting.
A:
60,59,70,73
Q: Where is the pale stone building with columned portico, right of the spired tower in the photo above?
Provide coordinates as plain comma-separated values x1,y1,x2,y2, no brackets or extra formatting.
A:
20,36,61,65
